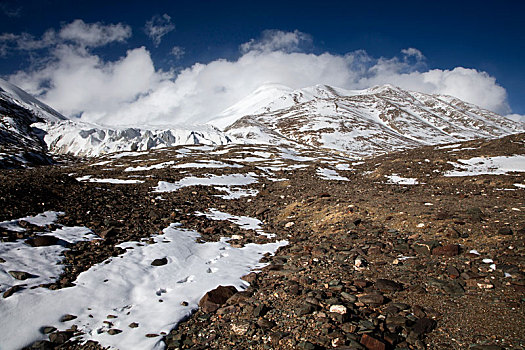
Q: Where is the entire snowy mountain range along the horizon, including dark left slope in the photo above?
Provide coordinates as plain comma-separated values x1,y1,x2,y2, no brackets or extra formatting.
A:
0,79,525,167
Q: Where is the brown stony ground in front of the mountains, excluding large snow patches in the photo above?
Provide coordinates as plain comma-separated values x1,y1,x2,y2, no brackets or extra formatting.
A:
0,134,525,349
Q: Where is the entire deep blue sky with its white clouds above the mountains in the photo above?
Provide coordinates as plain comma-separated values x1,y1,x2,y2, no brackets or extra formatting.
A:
0,0,525,123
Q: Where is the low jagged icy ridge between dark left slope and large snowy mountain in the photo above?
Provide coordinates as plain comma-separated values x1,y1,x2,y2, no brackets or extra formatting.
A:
34,120,231,157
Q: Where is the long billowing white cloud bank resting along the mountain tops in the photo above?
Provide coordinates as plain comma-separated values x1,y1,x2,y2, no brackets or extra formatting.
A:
10,31,510,125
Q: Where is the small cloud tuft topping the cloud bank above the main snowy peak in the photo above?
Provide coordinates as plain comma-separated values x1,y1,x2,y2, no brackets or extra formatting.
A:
240,29,312,53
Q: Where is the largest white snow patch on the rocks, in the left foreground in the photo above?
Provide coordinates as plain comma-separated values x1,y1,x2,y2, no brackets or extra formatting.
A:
0,225,287,350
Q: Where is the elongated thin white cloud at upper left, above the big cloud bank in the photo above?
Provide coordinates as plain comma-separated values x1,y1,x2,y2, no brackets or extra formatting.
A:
58,19,131,47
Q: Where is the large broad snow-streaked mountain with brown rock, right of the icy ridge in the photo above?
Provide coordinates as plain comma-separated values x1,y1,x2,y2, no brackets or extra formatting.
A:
219,85,525,156
